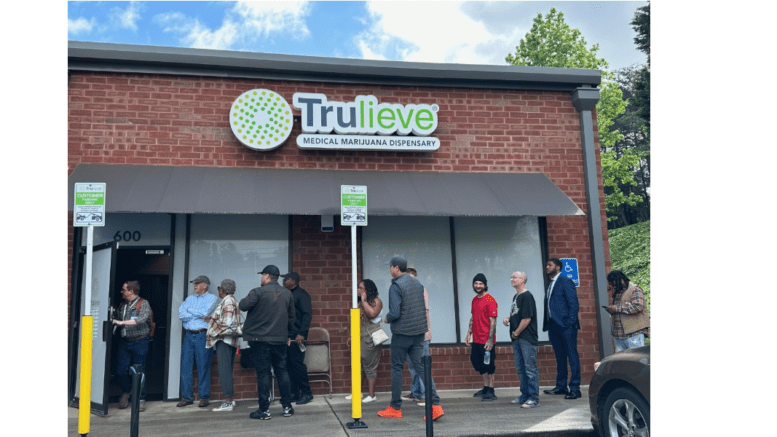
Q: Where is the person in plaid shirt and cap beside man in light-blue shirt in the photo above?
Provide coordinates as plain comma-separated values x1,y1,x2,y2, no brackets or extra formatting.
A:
205,279,240,411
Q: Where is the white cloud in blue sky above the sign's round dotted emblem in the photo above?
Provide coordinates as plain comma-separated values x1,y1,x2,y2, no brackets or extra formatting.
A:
154,1,310,49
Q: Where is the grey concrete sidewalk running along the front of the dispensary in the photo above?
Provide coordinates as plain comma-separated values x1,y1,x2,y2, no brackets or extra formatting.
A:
68,386,592,437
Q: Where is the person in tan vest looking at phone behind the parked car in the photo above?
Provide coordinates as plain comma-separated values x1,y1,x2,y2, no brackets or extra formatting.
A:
605,270,650,352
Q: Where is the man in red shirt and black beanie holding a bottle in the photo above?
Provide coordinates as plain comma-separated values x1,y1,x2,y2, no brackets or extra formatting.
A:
464,273,498,401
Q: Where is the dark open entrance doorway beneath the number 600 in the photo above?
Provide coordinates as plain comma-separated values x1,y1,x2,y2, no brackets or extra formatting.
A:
109,247,170,402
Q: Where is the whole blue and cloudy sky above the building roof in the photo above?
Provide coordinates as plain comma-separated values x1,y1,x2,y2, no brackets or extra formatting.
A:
67,1,647,71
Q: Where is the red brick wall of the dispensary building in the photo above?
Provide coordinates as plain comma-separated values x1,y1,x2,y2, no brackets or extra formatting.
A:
68,72,609,399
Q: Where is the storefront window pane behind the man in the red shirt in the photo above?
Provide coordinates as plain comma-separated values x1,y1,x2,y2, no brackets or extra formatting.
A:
453,216,548,342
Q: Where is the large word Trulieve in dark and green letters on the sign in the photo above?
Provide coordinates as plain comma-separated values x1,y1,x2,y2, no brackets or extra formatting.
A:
293,93,439,136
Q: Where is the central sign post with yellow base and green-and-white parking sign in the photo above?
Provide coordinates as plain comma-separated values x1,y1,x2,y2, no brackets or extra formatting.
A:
340,185,367,429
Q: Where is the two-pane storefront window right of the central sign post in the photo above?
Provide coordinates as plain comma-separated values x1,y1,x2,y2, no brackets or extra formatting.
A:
362,217,548,343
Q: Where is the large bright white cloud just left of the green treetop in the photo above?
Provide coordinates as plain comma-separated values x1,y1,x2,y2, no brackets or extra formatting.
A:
355,2,525,65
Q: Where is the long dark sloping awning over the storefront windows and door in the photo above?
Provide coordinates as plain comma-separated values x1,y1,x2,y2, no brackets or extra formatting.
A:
68,164,583,217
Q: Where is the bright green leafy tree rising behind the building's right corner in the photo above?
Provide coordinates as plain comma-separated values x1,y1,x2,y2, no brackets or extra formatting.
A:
505,8,642,221
